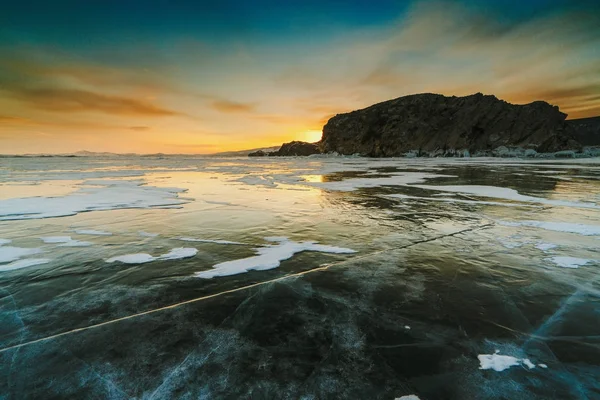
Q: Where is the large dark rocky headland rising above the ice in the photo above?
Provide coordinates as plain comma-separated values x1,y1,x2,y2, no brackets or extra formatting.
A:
321,93,581,157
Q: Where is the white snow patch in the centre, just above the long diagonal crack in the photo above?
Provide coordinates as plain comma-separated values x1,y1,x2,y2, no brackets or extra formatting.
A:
194,237,356,279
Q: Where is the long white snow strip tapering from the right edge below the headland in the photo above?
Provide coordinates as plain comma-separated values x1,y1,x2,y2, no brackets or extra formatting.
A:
414,185,600,209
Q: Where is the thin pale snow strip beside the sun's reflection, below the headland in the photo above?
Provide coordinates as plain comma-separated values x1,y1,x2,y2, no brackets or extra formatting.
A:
302,172,454,192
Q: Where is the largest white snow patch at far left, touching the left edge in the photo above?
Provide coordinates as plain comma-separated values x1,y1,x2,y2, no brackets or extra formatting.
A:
0,180,187,221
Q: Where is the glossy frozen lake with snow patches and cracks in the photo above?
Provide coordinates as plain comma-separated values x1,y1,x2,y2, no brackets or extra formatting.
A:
0,156,600,400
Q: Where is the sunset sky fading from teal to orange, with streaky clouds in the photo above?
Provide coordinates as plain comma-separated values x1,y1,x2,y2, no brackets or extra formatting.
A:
0,0,600,154
